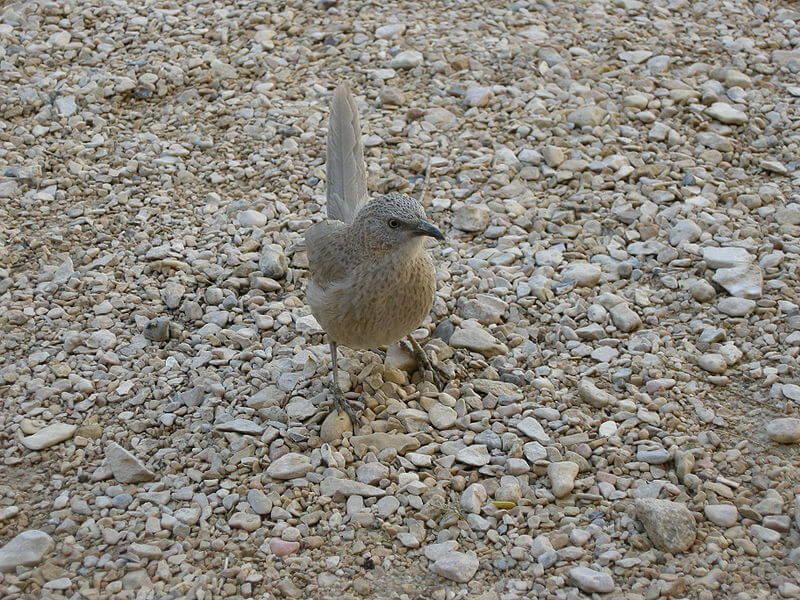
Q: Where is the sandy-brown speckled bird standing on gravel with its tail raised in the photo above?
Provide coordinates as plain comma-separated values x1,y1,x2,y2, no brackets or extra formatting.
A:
305,82,445,422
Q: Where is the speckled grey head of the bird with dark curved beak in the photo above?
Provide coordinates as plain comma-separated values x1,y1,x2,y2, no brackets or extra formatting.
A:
353,192,444,250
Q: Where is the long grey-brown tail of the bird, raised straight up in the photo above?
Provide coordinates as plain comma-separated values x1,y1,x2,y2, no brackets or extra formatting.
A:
326,83,367,223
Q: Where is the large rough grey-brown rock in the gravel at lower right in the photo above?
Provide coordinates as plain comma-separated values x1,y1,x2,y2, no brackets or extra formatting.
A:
635,498,697,554
